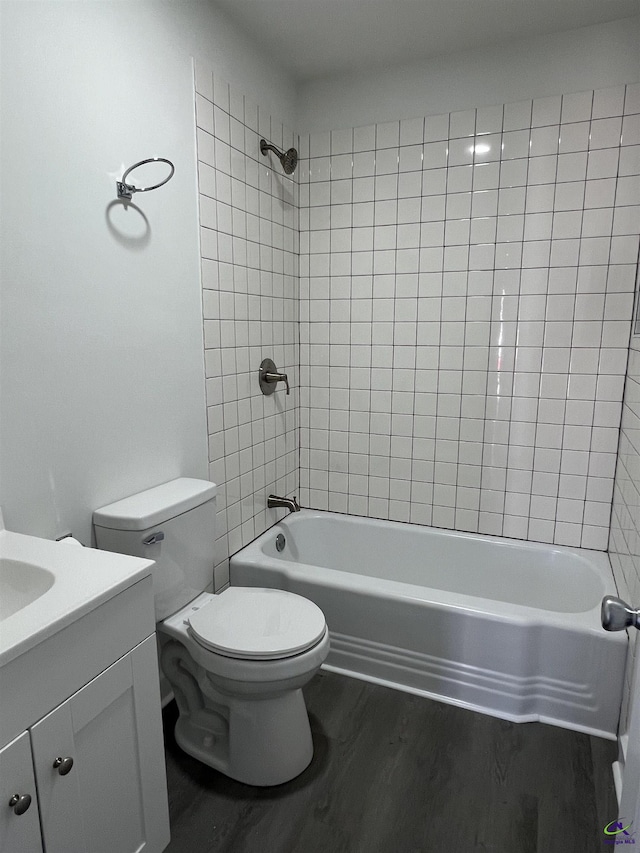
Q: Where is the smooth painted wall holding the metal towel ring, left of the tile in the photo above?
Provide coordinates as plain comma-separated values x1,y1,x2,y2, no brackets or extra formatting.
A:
0,0,293,543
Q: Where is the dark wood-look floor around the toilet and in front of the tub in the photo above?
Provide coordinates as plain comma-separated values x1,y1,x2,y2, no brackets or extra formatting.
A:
165,672,617,853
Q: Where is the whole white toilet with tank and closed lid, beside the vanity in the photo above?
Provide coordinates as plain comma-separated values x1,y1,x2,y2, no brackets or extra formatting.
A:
93,477,329,785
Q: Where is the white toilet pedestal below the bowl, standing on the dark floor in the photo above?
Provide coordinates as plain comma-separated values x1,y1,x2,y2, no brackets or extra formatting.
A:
162,640,314,786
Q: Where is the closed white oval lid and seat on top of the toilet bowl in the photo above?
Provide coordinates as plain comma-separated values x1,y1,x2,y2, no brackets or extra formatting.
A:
189,587,327,660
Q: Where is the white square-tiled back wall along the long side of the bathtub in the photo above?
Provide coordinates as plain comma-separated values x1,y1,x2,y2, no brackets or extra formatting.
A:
300,84,640,549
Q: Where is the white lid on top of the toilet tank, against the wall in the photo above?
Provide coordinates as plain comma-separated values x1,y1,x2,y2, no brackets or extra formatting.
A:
93,477,217,530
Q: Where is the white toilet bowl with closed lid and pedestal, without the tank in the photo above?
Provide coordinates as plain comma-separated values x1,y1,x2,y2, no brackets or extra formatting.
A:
158,587,329,785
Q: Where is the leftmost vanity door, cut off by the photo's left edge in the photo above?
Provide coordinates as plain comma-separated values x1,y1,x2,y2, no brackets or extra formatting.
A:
0,732,42,853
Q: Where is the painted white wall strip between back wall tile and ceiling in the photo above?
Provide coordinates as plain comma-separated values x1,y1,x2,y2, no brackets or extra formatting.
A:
296,17,640,133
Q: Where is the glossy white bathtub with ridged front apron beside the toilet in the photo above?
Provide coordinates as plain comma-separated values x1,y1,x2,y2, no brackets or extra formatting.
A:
231,510,627,739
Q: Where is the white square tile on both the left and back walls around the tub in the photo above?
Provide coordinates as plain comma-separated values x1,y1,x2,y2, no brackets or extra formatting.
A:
196,66,640,564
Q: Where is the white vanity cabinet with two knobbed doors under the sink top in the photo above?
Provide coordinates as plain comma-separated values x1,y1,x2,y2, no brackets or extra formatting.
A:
0,560,169,853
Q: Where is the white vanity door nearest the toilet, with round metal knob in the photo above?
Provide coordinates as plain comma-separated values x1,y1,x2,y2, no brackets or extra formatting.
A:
31,637,169,853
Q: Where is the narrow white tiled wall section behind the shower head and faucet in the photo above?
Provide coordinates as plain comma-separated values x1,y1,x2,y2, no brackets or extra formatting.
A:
195,64,299,589
